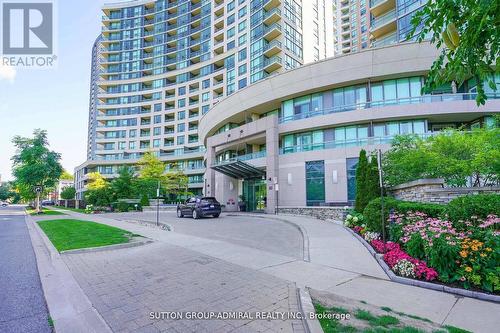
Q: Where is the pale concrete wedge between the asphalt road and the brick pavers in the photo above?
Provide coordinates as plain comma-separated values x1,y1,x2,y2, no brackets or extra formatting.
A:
26,215,112,333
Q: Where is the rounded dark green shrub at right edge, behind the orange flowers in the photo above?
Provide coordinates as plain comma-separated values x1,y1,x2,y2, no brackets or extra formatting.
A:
446,194,500,228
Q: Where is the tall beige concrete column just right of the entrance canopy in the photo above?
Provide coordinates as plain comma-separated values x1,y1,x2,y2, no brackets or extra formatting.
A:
266,115,279,214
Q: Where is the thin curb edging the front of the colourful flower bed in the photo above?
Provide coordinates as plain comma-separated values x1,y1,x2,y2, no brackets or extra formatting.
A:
344,226,500,303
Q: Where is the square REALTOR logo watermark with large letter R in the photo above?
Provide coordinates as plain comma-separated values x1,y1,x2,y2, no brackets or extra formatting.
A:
0,0,57,68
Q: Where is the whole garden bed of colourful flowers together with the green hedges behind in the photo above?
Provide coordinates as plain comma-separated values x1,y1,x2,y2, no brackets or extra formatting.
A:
344,194,500,295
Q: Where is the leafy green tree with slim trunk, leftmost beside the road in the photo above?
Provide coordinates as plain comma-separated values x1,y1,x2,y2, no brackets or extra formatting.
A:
11,129,63,212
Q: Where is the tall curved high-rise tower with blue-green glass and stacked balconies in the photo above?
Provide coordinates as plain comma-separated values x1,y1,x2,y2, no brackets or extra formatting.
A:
75,0,334,198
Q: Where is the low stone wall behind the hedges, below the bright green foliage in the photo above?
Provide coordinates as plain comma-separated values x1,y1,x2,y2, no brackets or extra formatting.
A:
389,179,500,204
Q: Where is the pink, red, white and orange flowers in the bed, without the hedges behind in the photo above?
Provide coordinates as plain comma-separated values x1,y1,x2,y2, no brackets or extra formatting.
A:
344,211,500,294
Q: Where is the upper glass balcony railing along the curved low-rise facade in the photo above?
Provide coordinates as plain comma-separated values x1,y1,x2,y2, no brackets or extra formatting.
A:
279,93,500,123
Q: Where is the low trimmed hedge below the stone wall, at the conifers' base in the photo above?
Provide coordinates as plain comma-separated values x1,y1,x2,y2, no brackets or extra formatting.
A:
363,197,446,232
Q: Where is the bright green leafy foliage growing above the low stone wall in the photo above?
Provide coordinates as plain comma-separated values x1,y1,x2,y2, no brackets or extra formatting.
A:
383,128,500,186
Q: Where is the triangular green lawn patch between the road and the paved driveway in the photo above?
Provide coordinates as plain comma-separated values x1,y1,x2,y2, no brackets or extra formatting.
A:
38,219,138,252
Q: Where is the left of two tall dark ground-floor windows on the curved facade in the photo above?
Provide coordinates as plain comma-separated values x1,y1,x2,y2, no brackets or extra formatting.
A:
306,161,325,206
